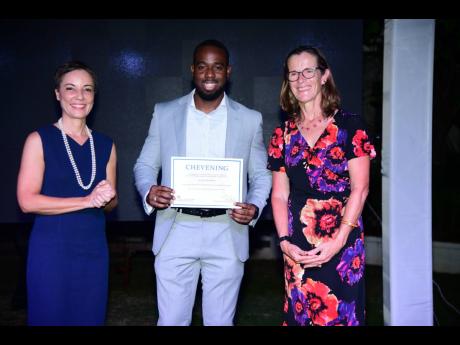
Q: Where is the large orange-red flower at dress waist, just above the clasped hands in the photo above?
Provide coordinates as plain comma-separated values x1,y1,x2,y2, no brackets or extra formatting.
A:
300,198,342,245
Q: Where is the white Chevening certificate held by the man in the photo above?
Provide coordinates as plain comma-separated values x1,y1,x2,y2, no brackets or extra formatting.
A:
171,157,243,208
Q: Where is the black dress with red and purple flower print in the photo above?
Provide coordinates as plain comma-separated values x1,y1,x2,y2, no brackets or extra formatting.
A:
268,110,376,326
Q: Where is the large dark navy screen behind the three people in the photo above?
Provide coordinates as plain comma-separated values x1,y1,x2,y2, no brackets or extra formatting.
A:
0,19,363,223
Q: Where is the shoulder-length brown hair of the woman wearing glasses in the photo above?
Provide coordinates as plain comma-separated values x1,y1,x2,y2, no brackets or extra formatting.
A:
280,45,340,121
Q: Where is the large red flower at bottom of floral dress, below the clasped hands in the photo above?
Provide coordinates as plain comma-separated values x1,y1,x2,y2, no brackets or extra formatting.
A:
301,278,339,326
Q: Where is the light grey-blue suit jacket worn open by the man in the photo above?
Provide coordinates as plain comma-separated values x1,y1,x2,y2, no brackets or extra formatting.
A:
134,91,272,261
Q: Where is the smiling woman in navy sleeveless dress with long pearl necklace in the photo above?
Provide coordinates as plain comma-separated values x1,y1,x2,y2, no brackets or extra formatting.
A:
17,61,117,325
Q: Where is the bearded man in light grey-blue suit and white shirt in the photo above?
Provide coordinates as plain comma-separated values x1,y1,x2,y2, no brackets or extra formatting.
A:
134,40,271,326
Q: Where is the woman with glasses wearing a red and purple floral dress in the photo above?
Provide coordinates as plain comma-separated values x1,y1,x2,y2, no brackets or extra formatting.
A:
268,46,376,326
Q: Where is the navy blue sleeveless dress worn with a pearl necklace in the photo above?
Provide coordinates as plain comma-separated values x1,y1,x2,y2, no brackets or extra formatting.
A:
27,125,113,326
